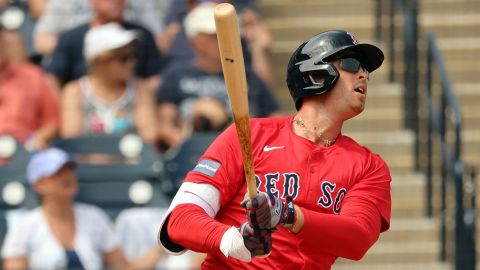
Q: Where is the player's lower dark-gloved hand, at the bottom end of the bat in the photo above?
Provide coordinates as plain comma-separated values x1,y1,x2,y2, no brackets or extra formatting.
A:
240,222,272,257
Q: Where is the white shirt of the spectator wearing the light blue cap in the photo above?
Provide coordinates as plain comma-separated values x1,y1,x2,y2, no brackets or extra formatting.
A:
1,203,118,269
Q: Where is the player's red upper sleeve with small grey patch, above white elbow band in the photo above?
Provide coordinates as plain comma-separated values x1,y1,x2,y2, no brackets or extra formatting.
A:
185,125,245,207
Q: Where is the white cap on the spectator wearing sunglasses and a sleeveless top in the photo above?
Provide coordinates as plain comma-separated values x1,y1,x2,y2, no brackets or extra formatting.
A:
83,22,138,62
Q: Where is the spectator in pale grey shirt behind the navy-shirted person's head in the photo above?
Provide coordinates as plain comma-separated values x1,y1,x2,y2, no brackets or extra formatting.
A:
34,0,171,55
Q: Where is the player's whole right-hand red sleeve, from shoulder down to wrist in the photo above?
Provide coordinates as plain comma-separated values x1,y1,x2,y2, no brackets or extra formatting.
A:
298,154,391,260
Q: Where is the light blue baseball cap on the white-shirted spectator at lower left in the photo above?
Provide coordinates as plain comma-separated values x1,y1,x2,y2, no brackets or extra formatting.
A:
27,148,75,185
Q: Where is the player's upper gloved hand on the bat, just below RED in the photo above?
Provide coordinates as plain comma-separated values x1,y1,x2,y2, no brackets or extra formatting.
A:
240,192,295,229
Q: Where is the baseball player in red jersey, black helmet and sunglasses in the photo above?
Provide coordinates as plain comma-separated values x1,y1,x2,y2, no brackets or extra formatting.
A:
158,30,391,270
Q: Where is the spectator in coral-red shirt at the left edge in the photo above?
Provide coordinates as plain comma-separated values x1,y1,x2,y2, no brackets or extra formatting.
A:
0,25,60,150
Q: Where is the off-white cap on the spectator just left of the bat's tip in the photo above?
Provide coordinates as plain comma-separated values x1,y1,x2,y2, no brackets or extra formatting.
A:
183,2,217,38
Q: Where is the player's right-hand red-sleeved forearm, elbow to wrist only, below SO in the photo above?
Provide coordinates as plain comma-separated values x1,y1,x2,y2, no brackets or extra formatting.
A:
298,204,381,260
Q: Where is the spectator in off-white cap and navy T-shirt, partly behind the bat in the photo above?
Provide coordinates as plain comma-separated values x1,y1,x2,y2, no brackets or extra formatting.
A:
157,3,278,148
